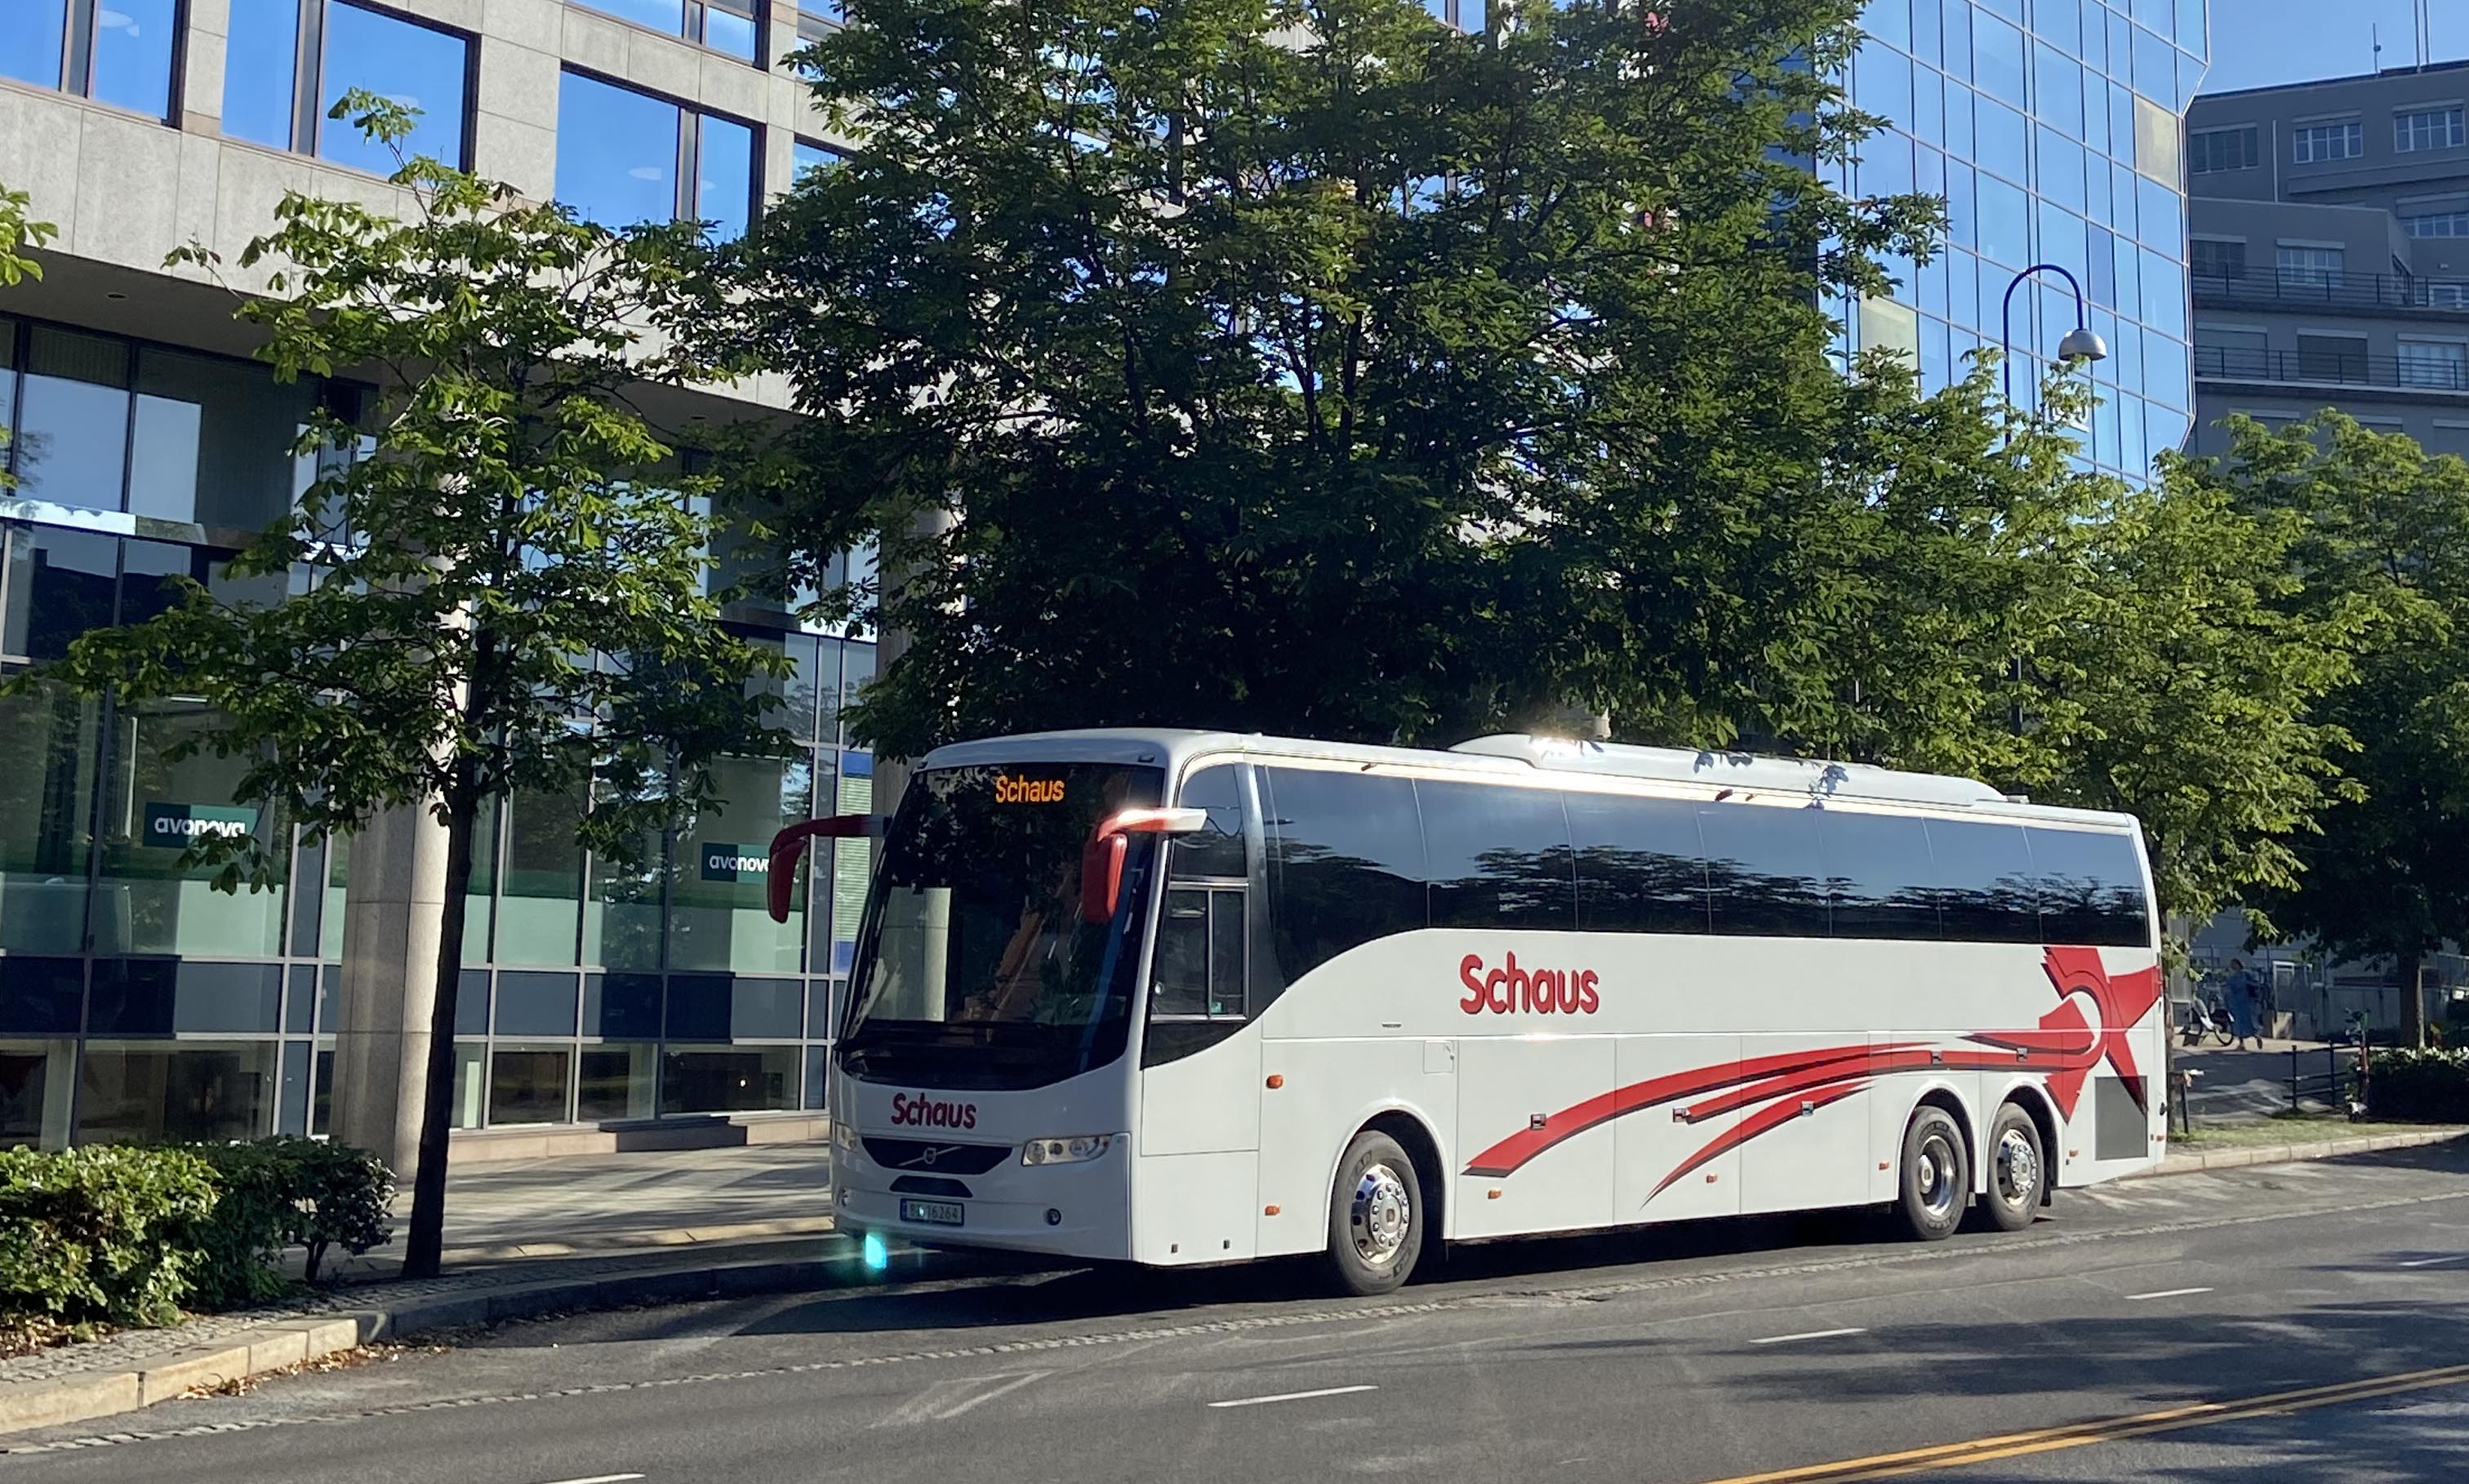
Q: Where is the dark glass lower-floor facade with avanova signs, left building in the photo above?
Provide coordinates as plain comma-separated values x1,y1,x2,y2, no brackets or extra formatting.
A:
0,318,874,1149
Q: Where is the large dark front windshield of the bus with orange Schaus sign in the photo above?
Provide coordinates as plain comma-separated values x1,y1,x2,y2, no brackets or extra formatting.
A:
839,763,1165,1086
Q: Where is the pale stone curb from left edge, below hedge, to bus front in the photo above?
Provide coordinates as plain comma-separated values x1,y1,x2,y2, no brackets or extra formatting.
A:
0,1239,842,1452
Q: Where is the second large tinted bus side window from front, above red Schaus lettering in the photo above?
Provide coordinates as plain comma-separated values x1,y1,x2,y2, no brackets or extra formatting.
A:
1415,783,1577,931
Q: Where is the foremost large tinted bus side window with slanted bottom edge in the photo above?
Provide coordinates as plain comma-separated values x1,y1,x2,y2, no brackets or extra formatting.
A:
1261,768,1430,983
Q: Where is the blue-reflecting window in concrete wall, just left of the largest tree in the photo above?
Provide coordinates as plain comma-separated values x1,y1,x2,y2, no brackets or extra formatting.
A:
558,72,755,242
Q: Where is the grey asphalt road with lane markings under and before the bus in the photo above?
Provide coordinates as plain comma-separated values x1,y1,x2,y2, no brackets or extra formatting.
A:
0,1146,2469,1484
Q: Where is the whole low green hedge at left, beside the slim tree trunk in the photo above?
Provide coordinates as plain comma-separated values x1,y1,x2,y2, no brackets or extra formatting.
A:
0,1135,395,1326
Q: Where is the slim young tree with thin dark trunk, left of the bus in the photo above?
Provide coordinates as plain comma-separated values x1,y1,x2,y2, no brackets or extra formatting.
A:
11,94,770,1277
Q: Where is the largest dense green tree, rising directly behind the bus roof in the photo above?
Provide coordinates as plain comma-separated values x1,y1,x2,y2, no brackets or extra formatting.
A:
710,0,1936,756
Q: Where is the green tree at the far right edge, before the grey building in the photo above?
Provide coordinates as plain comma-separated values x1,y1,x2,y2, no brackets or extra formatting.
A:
2202,410,2469,1045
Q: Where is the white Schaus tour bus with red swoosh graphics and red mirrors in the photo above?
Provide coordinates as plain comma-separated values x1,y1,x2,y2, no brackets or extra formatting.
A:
770,731,2168,1294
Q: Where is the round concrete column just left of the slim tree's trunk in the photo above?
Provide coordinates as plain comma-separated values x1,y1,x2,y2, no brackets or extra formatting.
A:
331,807,447,1188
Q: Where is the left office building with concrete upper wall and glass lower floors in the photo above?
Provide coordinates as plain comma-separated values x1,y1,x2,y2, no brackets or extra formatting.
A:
0,0,874,1149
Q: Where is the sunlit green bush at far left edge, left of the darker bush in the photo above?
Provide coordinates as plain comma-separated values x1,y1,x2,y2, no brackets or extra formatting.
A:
0,1146,215,1323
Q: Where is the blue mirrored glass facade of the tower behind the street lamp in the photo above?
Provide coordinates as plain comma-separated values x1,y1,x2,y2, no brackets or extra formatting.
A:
1837,0,2209,479
